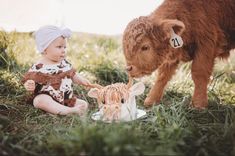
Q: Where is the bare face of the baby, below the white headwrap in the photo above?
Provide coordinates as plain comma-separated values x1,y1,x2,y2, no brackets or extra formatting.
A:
44,37,66,63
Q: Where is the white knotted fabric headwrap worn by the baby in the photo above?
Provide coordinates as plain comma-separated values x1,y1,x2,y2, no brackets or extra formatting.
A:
34,25,72,53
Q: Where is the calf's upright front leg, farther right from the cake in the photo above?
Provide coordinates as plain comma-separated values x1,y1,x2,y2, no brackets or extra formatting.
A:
192,51,214,109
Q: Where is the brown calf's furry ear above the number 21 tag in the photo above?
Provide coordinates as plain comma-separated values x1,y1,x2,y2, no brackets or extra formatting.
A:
160,19,185,38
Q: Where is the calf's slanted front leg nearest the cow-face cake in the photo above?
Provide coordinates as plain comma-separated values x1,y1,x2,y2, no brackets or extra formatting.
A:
144,63,178,107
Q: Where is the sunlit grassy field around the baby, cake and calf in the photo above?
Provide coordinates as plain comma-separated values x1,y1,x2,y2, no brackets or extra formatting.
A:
0,32,235,156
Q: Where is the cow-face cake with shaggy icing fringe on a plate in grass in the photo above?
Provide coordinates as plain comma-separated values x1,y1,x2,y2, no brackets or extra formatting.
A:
88,81,146,122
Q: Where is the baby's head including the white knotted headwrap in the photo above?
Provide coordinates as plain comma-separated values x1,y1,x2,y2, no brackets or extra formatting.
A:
35,25,72,61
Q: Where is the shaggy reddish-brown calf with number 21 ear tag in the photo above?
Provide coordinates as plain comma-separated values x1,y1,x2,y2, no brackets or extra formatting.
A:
123,0,235,109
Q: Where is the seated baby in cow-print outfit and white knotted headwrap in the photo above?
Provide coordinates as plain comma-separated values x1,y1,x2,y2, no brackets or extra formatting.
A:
22,26,94,115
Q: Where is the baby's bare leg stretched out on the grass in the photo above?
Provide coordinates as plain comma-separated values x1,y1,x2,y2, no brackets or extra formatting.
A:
33,94,82,115
